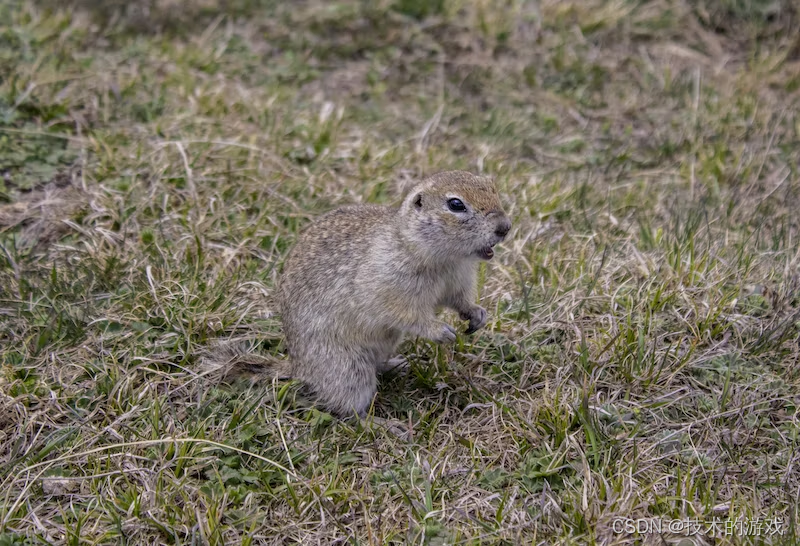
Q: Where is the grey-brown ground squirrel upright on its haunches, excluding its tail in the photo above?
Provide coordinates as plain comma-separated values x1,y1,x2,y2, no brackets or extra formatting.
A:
278,171,511,416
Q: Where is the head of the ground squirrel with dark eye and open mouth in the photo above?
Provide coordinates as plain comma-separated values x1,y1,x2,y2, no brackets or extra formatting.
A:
400,171,511,260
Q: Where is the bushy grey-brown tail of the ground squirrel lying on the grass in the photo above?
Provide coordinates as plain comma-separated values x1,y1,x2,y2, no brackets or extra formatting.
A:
200,343,290,383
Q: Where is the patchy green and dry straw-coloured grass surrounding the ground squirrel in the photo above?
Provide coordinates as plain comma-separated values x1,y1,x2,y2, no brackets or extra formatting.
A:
0,0,800,546
